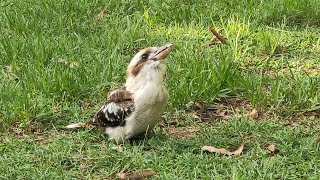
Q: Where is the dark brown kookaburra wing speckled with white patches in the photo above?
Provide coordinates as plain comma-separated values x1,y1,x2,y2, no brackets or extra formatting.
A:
93,87,134,127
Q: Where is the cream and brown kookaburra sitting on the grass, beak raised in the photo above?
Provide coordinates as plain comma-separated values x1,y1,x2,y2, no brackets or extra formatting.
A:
67,44,173,144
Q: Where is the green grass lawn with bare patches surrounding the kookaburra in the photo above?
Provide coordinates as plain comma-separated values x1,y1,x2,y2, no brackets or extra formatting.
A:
0,0,320,179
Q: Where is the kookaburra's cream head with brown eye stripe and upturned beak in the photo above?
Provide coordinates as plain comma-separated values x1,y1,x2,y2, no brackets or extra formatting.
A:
126,43,173,88
